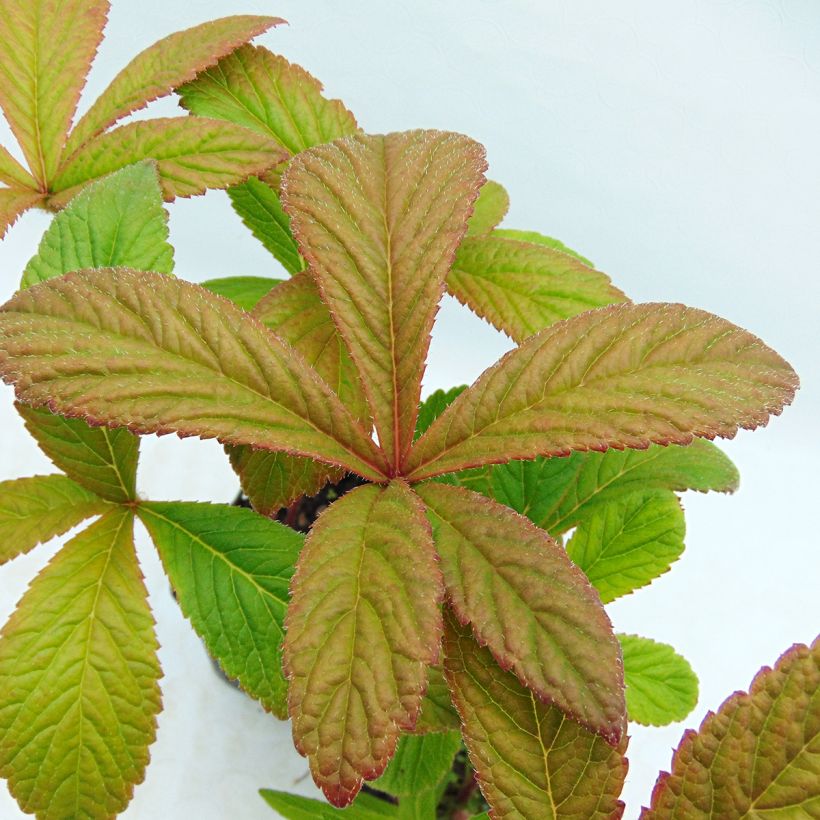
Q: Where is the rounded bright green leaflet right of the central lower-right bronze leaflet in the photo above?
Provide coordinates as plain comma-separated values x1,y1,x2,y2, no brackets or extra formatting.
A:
567,490,686,604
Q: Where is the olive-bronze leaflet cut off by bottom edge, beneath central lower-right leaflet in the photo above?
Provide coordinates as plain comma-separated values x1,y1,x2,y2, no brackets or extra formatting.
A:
444,617,626,820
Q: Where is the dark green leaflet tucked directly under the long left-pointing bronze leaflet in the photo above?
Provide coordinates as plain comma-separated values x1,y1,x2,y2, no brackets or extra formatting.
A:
17,404,139,504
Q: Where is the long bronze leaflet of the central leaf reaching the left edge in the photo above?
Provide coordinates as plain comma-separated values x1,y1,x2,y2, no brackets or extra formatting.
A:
0,269,390,480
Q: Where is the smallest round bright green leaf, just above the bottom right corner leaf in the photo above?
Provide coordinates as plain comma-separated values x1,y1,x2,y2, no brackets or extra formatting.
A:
618,635,698,726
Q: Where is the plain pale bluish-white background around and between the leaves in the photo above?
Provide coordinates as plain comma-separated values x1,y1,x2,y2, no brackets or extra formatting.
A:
0,0,820,820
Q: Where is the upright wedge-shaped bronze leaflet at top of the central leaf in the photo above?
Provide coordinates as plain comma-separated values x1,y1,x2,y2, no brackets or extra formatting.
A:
283,131,486,473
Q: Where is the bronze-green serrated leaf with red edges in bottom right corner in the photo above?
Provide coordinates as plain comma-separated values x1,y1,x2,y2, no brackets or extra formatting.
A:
641,639,820,820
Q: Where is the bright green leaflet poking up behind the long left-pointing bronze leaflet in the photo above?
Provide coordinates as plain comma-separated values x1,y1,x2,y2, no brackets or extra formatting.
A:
20,162,174,288
